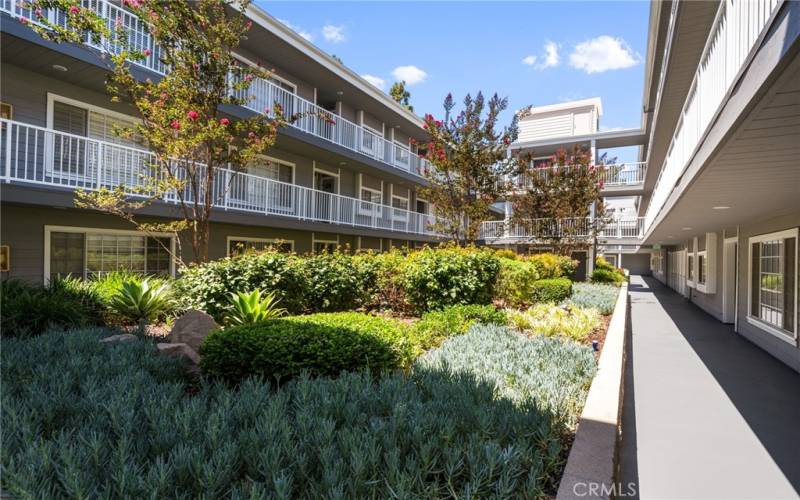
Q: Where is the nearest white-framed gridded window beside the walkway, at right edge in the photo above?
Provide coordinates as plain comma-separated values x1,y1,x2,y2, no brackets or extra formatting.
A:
748,229,798,338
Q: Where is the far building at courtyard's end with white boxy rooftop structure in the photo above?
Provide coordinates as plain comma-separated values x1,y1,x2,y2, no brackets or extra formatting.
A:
481,97,650,279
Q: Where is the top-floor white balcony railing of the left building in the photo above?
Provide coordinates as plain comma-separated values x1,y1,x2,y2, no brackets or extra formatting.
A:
0,0,429,177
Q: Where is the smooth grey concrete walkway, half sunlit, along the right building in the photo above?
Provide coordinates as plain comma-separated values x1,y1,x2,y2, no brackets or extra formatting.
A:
619,276,800,500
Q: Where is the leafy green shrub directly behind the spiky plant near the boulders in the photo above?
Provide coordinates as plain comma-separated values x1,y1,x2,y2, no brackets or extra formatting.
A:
175,251,305,322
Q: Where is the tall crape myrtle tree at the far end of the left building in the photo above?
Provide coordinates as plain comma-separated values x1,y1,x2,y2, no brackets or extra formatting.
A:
412,92,517,245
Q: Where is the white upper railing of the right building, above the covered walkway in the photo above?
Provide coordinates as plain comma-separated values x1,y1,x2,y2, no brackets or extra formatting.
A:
645,0,783,229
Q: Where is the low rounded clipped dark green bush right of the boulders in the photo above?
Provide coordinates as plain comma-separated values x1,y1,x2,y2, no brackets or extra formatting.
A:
200,313,408,382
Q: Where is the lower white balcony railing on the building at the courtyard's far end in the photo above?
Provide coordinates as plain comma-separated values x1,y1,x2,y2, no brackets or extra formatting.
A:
479,217,644,243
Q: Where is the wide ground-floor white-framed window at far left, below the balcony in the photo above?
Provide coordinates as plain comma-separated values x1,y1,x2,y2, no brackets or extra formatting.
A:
45,228,173,279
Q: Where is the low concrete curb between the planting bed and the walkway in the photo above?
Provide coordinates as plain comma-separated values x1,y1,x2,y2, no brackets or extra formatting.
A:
556,283,628,500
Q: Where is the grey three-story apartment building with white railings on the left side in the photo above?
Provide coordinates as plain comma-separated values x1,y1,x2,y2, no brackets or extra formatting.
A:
0,0,437,282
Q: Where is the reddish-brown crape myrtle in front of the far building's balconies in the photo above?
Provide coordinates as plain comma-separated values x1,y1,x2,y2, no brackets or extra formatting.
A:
512,147,606,255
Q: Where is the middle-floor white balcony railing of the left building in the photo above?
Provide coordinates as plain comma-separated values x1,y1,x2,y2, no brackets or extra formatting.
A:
0,120,444,236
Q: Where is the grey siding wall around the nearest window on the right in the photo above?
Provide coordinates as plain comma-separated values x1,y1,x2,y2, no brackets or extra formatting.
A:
736,212,800,372
